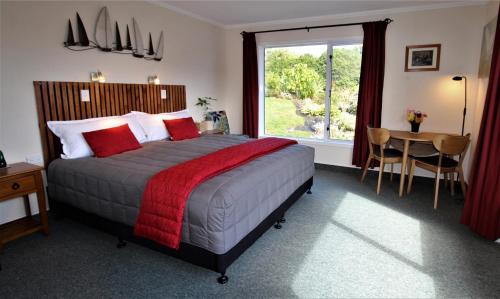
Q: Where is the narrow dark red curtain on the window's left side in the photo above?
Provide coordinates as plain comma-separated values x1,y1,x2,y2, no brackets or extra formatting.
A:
242,32,259,138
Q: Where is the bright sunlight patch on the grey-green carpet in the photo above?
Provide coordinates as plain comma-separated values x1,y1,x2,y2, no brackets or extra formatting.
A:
291,192,436,298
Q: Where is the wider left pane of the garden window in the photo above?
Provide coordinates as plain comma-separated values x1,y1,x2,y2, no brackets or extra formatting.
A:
264,44,327,139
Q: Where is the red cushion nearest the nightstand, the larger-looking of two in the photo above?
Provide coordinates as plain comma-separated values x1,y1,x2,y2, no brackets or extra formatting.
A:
82,124,142,158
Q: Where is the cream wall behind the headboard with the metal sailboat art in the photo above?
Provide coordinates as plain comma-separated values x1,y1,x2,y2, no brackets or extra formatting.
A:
0,1,224,222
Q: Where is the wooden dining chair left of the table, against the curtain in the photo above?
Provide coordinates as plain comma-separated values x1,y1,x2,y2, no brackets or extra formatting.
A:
361,127,403,195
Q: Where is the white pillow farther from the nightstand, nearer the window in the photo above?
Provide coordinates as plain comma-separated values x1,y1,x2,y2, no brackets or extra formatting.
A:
127,109,191,141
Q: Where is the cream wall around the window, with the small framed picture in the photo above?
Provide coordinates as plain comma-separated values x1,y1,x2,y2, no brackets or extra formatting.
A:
224,5,492,176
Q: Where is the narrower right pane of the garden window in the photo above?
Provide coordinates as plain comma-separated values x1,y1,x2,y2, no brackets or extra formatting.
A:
330,45,362,140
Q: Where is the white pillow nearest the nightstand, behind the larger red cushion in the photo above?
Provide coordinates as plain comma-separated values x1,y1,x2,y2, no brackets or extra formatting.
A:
47,115,147,159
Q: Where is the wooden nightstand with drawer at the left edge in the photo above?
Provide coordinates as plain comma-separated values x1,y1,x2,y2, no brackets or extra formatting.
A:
0,163,49,269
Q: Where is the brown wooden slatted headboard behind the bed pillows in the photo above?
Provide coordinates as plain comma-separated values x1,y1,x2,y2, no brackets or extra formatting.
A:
33,81,186,167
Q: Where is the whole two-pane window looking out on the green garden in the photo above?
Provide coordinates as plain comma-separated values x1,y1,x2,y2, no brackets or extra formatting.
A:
263,43,361,141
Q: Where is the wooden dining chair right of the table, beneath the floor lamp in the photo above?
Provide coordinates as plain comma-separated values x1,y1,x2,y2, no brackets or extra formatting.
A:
407,133,470,209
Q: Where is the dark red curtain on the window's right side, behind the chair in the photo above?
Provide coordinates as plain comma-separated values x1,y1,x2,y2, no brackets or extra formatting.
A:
352,21,388,167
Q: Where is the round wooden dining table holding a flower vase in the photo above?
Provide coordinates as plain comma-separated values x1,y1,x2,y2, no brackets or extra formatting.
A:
389,130,453,197
